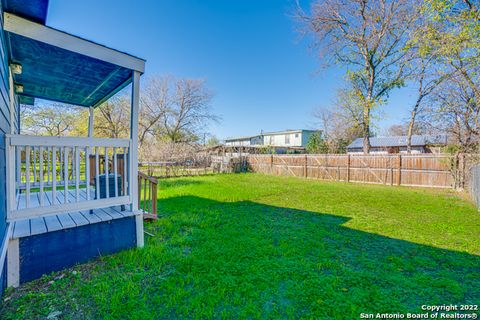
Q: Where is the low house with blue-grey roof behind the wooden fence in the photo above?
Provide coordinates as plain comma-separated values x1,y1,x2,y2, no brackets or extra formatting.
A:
347,135,448,154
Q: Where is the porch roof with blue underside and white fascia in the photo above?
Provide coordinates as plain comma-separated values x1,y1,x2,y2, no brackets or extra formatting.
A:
5,13,145,107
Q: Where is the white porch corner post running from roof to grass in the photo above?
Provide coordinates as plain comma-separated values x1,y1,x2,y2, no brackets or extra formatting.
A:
129,71,144,248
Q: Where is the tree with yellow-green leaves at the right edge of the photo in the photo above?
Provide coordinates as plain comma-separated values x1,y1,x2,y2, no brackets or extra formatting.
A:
412,0,480,152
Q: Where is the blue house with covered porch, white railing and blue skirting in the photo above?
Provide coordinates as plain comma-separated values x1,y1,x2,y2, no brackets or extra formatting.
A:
0,0,145,291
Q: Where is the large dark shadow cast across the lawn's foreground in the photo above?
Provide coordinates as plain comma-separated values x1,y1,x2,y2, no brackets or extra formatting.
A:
0,196,480,319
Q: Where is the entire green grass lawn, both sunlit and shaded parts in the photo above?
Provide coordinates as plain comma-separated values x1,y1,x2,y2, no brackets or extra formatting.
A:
0,174,480,319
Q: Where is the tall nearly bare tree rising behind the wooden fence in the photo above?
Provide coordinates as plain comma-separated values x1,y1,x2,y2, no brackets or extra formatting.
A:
298,0,419,153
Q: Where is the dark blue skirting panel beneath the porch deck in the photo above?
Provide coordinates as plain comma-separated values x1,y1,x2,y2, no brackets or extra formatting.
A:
20,216,136,283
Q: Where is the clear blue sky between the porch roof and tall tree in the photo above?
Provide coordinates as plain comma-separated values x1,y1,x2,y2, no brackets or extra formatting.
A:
47,0,411,139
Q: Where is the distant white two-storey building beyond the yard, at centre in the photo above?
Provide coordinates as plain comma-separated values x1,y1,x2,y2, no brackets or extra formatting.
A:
225,129,316,153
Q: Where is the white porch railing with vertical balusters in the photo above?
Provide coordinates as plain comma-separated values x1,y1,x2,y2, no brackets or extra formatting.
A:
6,135,133,221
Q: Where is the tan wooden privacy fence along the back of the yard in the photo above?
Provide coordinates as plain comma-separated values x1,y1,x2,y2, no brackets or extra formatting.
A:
247,154,458,188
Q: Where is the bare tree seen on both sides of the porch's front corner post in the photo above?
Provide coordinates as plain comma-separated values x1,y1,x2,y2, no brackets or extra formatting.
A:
95,76,219,147
